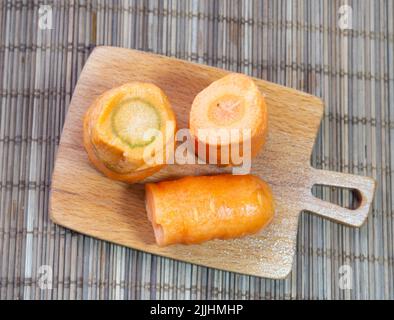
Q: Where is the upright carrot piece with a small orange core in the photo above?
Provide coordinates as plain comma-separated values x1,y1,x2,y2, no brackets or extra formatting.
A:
189,73,268,165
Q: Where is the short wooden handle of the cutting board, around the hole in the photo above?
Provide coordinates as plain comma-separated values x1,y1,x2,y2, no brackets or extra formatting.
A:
305,168,376,227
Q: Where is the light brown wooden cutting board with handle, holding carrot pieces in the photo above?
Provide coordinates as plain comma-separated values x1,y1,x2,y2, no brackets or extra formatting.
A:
50,47,375,279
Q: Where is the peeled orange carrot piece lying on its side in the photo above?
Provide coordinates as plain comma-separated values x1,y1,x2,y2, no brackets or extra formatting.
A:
145,175,274,246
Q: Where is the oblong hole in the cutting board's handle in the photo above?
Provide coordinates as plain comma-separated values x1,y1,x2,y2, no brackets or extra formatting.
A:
311,184,362,210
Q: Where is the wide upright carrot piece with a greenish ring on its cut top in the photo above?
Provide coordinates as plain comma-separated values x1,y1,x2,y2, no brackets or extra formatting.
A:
83,82,176,183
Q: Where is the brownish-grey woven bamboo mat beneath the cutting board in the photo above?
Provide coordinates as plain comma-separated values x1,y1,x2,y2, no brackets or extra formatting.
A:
0,0,394,299
